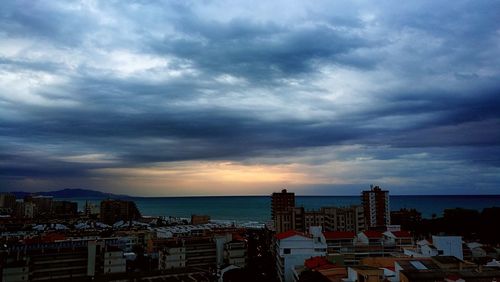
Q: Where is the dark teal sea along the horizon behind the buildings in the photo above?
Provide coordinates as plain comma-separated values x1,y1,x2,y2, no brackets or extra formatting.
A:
66,195,500,222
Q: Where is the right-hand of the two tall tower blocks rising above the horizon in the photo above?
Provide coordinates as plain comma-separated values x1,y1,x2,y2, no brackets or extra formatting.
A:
361,186,391,228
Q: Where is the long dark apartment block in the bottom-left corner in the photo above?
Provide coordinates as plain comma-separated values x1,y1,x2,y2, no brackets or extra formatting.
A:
2,239,126,281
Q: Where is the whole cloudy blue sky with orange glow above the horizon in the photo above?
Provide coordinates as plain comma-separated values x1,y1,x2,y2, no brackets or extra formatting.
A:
0,0,500,196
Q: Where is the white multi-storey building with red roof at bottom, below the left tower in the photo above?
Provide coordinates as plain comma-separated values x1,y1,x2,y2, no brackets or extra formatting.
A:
275,226,327,282
